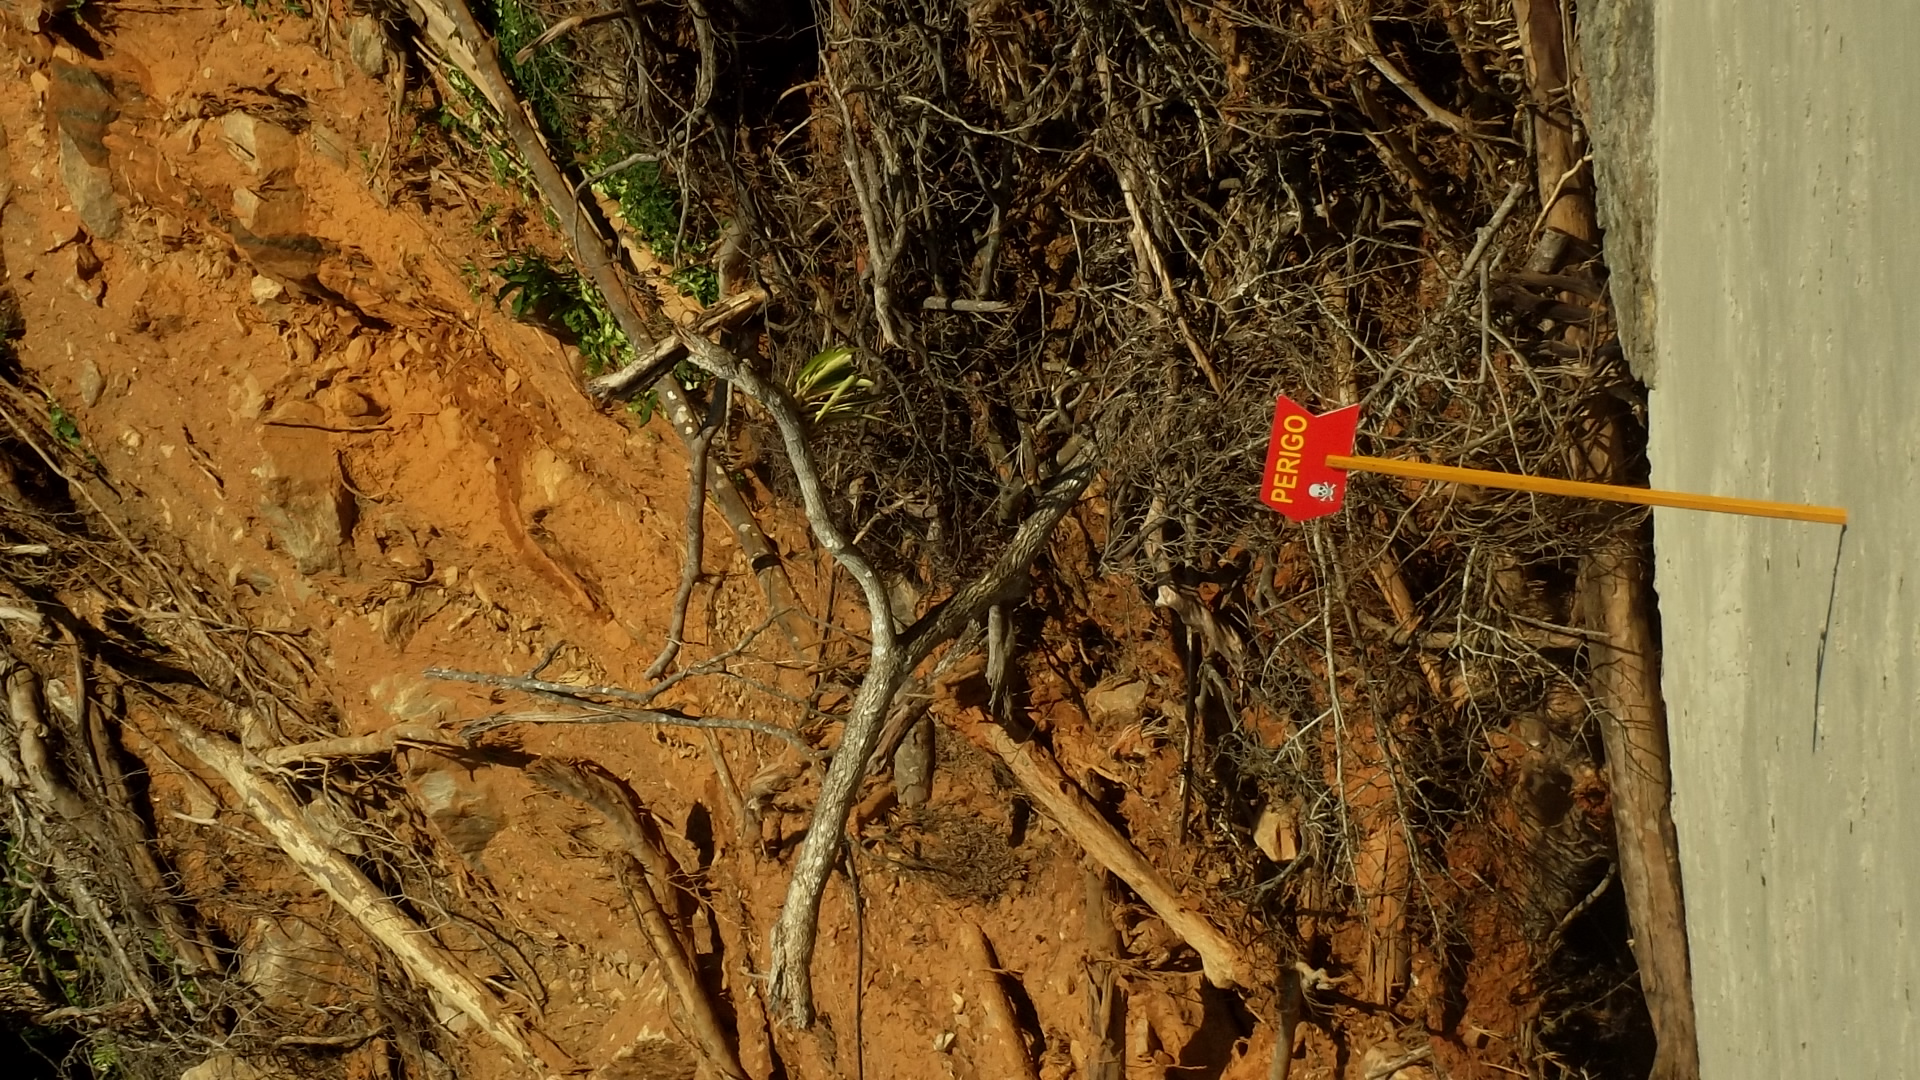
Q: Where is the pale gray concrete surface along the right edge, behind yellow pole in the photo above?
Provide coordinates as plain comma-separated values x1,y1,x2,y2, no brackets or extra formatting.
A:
1645,0,1920,1080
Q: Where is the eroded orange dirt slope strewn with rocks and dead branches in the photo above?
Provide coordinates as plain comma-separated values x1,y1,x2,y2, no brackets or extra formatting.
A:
0,6,1603,1080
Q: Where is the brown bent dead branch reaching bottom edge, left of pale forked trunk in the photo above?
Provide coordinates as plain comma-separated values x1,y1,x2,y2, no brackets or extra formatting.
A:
526,757,747,1080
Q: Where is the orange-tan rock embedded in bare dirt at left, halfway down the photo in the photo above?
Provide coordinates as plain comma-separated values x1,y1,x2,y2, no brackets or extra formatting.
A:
253,427,353,575
